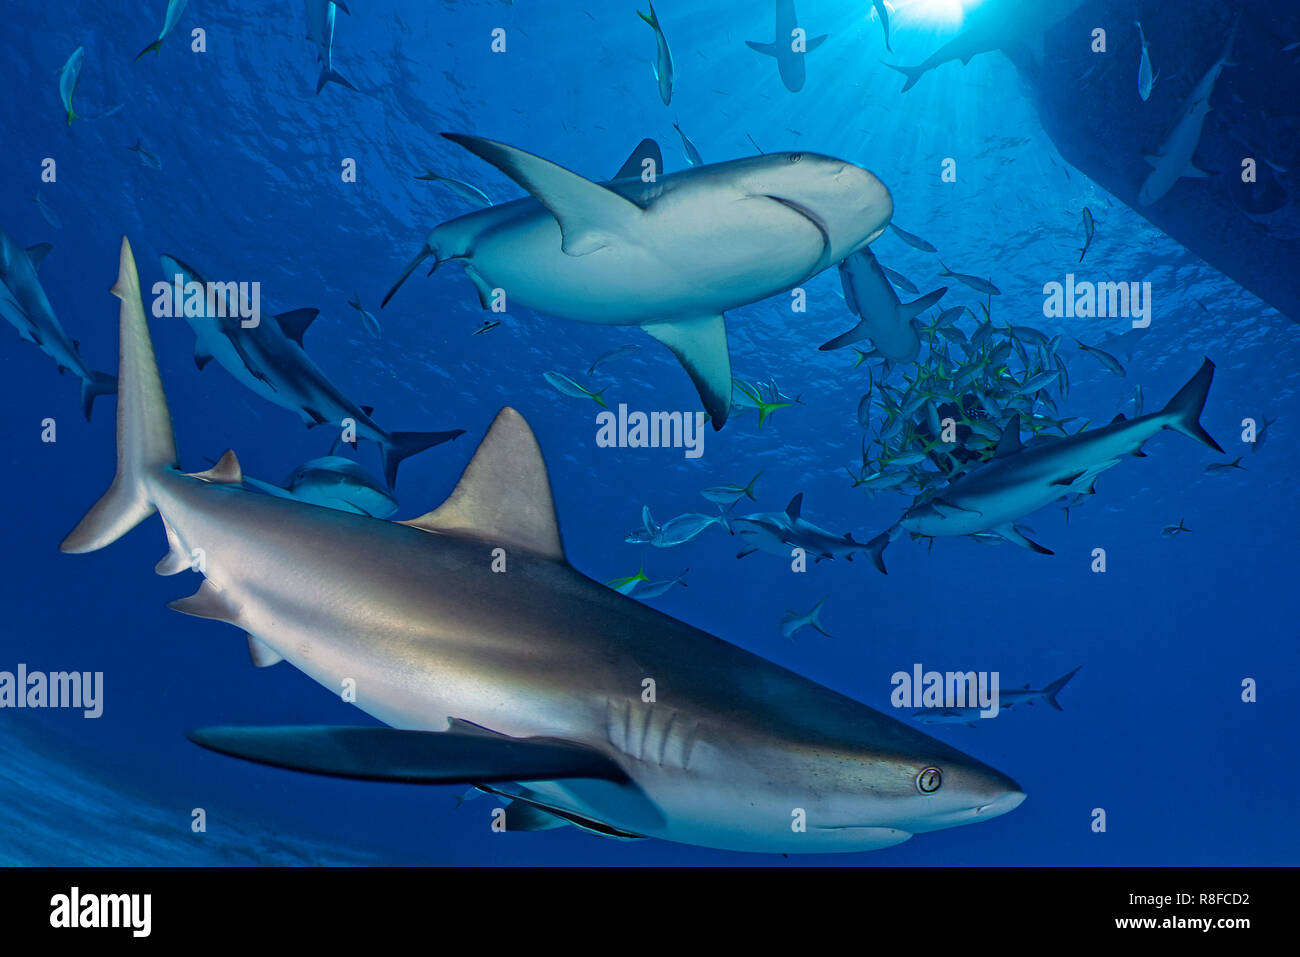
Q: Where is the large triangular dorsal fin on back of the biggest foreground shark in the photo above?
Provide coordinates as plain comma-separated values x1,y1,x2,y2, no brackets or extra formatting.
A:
399,406,564,559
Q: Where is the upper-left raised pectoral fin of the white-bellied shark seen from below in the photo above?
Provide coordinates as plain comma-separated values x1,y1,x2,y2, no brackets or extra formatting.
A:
442,133,642,256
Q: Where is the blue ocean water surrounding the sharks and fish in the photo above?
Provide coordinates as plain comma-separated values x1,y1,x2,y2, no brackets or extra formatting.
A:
0,0,1300,865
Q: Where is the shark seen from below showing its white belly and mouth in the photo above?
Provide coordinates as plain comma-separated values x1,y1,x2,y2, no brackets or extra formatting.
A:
384,133,893,429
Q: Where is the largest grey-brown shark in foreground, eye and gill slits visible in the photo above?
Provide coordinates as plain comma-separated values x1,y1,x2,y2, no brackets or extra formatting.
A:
61,241,1024,853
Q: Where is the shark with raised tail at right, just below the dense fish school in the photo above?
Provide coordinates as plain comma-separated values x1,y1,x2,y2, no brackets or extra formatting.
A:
868,359,1223,571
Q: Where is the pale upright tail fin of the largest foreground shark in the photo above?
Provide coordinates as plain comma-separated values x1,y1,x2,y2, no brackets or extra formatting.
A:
59,237,177,553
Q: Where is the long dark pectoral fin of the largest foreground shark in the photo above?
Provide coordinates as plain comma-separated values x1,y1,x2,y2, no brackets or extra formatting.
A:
186,726,627,784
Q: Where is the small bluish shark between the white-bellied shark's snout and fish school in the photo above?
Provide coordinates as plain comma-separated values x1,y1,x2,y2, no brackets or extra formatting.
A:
822,250,948,365
